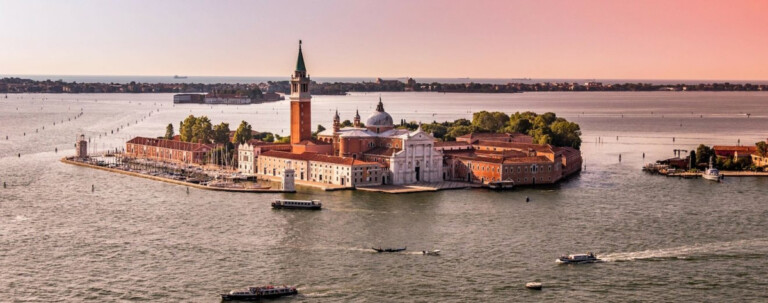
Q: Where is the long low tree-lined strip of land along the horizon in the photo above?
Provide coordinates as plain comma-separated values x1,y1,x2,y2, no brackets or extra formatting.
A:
0,78,768,95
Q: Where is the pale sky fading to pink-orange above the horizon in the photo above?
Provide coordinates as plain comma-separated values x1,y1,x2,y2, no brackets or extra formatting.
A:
0,0,768,80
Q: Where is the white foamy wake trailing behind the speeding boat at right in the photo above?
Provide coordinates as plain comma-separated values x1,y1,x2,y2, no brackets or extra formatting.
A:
598,238,768,262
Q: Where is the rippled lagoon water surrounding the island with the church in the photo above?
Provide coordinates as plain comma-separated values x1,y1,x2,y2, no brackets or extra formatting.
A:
0,92,768,302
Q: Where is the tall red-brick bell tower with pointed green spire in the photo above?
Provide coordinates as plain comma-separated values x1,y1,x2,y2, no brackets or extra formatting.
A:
290,40,312,144
